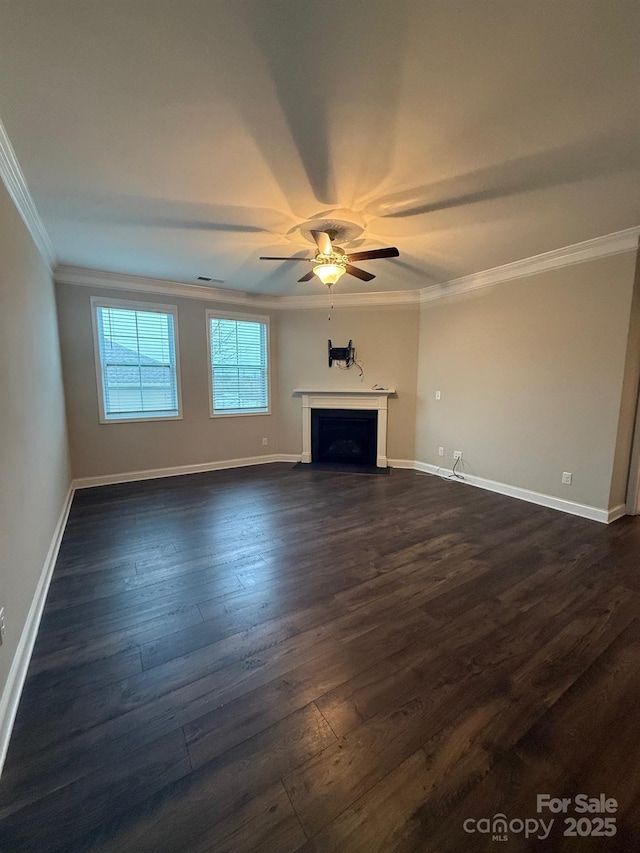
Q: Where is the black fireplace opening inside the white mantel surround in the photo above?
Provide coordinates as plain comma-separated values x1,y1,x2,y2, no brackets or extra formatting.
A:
311,409,378,467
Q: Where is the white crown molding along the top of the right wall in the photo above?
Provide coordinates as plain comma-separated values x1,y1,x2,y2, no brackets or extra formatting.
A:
420,225,640,302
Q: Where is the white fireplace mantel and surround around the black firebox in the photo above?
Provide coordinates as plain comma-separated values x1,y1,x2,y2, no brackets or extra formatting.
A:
293,388,396,468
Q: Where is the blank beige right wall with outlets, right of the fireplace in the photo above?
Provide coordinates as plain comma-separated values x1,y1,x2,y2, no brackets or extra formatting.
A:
416,253,635,508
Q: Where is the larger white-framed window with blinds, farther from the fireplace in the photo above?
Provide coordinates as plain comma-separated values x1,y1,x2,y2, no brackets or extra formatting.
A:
91,298,181,423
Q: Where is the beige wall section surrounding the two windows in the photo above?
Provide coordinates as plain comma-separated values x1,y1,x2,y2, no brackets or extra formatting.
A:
56,285,278,478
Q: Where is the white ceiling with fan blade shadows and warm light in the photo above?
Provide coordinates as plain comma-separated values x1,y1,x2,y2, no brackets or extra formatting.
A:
0,0,640,294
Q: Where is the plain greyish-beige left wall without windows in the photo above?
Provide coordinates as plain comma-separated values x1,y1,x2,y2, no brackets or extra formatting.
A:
0,182,70,691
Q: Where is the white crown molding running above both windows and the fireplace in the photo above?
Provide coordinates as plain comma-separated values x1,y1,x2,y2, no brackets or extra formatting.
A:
54,265,420,310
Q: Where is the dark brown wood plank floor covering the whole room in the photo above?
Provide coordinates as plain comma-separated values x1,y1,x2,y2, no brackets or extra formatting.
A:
0,465,640,853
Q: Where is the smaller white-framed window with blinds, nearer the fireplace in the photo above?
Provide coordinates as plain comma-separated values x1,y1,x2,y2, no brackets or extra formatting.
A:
207,311,269,417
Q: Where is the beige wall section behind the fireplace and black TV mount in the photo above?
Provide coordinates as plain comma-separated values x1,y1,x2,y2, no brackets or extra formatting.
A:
278,305,420,459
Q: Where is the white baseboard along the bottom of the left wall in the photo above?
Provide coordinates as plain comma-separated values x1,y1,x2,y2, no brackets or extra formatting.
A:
0,483,75,774
